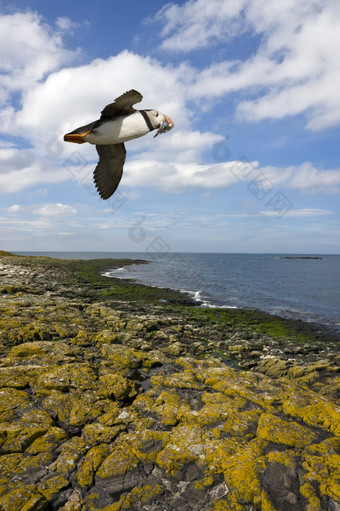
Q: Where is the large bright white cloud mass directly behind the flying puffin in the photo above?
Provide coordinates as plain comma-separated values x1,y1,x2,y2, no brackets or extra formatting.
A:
0,26,223,193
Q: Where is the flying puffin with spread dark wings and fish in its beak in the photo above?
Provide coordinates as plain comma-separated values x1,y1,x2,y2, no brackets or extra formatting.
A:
64,89,174,200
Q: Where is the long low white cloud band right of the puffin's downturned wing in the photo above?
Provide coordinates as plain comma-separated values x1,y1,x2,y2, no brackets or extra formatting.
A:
122,158,340,194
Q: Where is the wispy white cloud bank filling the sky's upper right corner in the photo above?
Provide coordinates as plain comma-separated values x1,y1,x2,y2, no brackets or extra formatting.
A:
155,0,340,130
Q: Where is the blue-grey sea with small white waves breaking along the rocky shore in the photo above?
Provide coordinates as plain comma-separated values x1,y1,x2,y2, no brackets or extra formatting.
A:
16,253,340,332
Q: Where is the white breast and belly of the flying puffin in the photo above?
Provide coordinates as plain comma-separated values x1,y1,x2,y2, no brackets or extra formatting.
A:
84,112,150,145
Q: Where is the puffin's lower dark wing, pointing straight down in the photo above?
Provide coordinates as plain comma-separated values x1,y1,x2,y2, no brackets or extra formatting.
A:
93,144,126,199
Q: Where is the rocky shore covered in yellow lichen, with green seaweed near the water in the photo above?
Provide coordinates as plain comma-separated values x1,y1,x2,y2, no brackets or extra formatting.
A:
0,252,340,511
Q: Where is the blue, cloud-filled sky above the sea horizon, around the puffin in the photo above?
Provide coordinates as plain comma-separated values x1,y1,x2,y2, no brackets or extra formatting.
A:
0,0,340,257
